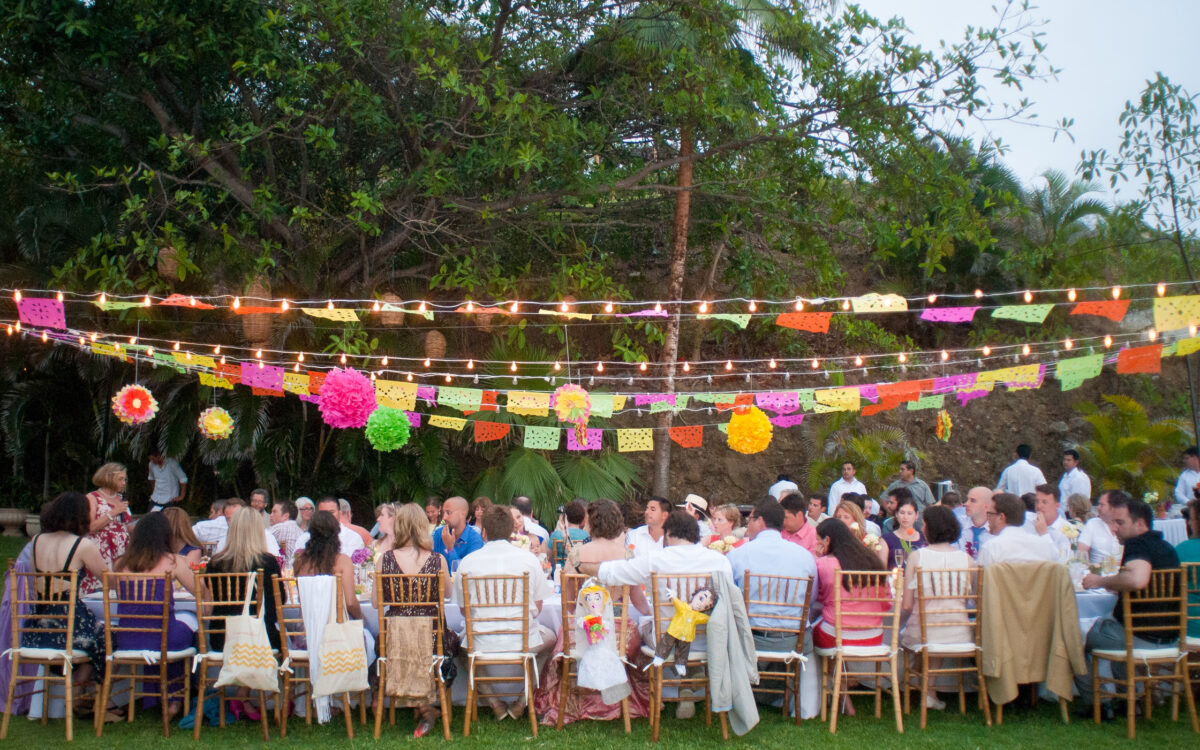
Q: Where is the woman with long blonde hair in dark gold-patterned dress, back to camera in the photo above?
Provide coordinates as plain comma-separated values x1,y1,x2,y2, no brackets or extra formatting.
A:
371,503,460,738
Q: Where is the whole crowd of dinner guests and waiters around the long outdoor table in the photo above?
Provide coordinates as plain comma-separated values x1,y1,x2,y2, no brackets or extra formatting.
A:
7,445,1200,736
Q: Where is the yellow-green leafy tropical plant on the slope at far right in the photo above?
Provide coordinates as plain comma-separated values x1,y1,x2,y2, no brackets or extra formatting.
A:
1075,395,1192,497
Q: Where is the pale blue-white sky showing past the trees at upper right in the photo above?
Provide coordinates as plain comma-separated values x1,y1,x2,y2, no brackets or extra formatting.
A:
854,0,1200,200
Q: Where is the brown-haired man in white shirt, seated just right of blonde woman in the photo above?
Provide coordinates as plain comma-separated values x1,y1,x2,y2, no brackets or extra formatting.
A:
448,500,557,719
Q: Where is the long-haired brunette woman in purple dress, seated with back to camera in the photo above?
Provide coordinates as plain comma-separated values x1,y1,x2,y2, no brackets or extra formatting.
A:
113,508,196,716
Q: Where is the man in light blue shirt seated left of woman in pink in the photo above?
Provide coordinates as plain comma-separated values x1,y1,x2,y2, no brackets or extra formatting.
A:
727,497,817,704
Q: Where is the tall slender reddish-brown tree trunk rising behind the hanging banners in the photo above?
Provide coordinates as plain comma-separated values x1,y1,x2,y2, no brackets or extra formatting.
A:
654,124,696,497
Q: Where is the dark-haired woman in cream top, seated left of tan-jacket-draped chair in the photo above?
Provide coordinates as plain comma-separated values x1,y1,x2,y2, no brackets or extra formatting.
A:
900,504,974,710
